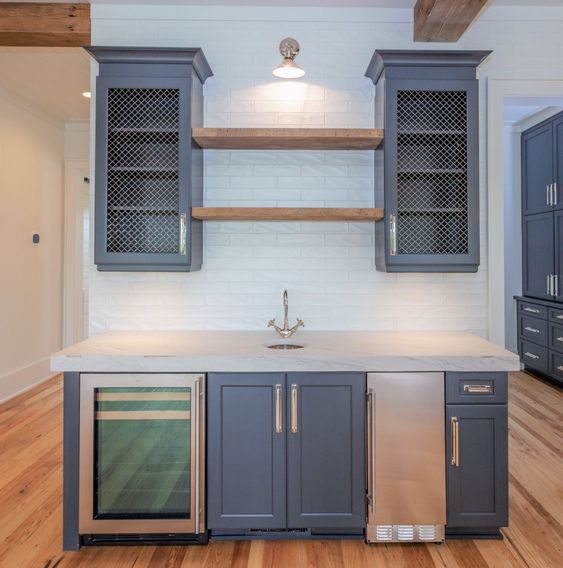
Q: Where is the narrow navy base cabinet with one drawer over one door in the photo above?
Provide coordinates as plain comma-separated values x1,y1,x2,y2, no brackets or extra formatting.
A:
446,373,508,538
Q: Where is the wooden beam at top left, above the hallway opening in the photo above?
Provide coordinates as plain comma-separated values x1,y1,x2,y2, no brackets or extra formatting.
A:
0,2,90,47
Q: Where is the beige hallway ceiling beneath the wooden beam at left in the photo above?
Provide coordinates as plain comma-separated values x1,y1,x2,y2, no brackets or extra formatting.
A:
0,47,90,121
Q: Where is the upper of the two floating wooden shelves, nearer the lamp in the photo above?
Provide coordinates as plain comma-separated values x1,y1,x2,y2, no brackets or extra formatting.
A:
192,128,383,150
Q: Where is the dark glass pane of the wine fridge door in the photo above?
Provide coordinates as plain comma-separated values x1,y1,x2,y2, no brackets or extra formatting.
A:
94,387,191,519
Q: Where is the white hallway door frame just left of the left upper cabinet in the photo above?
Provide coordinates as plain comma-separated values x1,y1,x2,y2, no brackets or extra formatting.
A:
63,160,90,347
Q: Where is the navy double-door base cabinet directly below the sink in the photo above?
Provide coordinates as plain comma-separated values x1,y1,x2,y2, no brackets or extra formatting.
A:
207,373,366,538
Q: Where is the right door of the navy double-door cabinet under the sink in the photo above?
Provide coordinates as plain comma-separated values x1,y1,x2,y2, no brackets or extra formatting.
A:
287,373,366,528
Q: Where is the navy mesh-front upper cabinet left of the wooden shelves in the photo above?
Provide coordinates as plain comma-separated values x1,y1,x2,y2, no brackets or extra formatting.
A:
87,47,212,271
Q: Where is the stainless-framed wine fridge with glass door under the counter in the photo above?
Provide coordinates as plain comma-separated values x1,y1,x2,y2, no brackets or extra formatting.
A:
79,374,205,538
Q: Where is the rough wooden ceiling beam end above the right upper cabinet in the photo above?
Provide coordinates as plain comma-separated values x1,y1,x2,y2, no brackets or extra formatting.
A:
414,0,489,42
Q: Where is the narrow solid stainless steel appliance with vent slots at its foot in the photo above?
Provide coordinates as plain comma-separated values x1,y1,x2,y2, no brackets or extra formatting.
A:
366,373,446,542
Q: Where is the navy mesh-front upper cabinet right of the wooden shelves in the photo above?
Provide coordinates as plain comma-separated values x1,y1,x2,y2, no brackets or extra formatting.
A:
366,50,490,272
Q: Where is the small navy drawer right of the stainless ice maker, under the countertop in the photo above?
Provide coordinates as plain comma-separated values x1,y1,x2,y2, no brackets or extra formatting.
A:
446,373,508,404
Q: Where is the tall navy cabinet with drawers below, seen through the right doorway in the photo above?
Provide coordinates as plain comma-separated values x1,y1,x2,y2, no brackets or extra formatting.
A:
517,112,563,384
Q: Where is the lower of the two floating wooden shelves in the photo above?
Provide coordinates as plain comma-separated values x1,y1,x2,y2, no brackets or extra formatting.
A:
192,207,383,221
